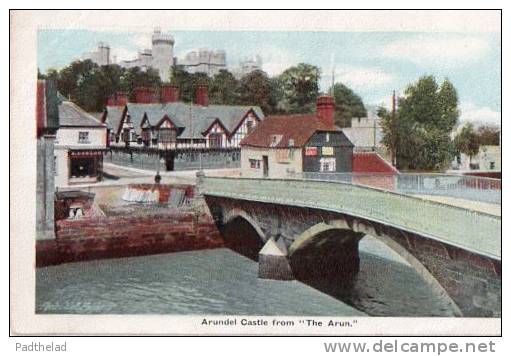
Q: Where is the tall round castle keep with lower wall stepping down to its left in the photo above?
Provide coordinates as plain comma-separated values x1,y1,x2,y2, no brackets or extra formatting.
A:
119,28,174,82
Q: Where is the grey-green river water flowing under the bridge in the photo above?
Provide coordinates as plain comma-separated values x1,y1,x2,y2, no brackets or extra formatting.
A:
36,238,452,316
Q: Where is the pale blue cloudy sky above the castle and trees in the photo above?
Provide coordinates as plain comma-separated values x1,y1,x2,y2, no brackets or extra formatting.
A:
37,27,501,124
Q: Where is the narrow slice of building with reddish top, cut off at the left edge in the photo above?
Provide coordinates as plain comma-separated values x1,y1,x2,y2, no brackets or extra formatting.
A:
36,80,59,240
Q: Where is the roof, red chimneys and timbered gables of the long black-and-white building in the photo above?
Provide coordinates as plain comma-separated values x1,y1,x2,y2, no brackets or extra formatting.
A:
102,85,264,149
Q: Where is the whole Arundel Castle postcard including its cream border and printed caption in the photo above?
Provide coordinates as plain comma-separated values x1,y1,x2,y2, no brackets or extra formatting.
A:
10,10,502,336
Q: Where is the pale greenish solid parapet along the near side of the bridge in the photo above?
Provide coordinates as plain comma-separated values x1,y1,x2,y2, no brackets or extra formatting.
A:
199,177,501,259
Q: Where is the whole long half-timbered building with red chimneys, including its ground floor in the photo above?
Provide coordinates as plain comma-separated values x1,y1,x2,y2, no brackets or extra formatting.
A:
101,85,264,170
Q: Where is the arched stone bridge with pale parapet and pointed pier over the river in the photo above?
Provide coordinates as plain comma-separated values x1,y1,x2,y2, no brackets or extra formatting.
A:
198,175,501,317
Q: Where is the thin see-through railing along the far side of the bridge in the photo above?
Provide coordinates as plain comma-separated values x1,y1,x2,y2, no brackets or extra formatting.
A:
289,172,501,204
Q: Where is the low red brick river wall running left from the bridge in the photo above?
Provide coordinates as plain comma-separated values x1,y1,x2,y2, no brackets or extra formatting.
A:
36,211,223,267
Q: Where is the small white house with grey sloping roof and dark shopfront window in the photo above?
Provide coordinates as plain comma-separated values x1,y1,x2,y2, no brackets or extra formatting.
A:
55,94,107,187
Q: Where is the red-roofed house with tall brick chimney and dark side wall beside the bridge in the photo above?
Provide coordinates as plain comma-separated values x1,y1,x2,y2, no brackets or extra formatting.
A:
240,96,353,178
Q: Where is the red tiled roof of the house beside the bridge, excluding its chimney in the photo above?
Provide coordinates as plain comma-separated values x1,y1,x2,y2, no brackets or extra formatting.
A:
240,115,338,148
